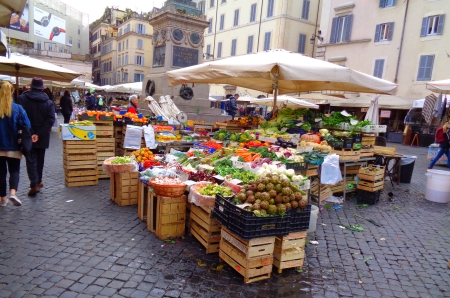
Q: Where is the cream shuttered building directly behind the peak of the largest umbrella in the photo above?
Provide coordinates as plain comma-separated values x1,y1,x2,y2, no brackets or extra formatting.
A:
202,0,321,96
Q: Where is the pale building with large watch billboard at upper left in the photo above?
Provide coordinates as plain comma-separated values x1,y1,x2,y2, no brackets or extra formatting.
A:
3,0,92,81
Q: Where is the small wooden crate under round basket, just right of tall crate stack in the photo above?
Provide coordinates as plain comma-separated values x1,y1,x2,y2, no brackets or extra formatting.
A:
110,172,139,206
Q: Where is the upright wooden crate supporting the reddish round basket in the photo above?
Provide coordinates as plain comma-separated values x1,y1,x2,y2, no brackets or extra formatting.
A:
147,193,186,240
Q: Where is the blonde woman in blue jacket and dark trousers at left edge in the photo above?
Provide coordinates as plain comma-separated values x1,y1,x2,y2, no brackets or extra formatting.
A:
0,81,31,207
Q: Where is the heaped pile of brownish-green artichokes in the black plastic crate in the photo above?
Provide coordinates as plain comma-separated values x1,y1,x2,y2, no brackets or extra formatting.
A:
233,173,308,216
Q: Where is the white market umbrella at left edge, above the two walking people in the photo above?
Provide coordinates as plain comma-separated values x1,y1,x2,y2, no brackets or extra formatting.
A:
0,53,80,92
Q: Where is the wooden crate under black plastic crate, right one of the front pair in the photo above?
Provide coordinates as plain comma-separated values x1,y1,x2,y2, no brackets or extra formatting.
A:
273,231,306,273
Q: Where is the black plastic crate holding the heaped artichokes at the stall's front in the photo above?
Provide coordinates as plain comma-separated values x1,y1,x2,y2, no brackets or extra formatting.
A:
213,195,291,240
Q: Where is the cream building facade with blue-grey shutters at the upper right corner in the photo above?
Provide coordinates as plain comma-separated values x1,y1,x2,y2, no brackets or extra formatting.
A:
317,0,450,99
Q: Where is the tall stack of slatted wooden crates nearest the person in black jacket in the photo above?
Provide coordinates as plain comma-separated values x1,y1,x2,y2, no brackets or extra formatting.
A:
63,140,98,187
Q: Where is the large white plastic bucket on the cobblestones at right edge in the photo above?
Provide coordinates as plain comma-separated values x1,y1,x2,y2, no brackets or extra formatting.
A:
425,170,450,203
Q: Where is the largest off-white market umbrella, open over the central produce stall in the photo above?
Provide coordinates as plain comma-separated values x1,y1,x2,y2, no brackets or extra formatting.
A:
167,50,397,112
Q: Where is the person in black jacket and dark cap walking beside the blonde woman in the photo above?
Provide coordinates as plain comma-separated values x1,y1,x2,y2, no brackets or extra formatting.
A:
17,78,55,196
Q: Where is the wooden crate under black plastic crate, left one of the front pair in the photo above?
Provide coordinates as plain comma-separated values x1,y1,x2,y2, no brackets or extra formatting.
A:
219,227,275,283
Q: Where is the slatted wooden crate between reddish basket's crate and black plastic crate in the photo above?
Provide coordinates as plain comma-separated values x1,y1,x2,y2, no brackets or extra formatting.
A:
190,204,220,254
